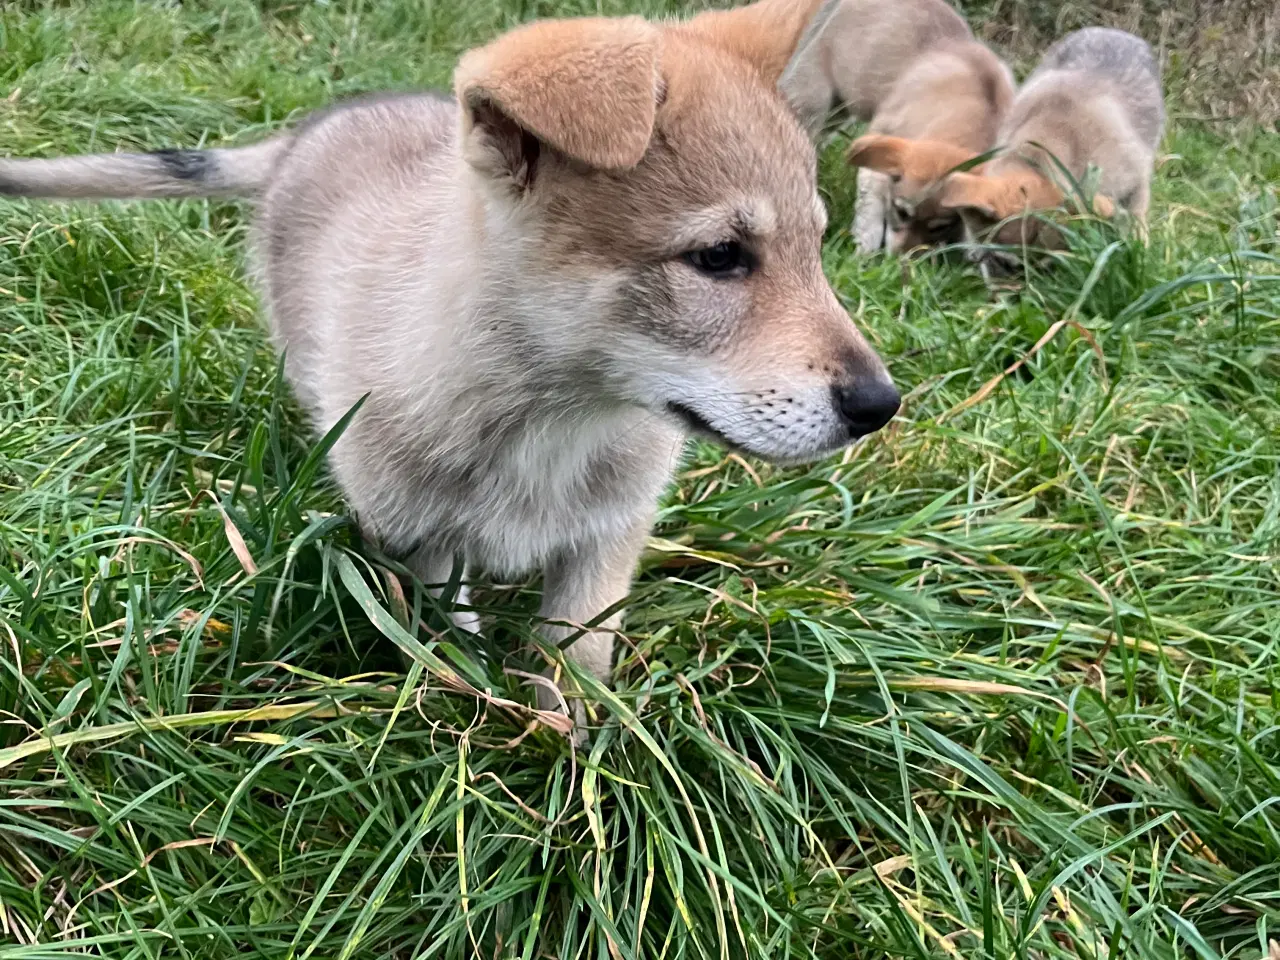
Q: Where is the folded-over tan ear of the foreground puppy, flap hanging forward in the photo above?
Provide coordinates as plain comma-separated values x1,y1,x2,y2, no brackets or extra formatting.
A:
453,17,662,186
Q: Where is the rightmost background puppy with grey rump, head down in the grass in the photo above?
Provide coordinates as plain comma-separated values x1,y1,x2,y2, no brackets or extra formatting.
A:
938,27,1165,274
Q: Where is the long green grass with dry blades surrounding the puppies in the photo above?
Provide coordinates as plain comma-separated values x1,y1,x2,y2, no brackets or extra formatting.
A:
0,0,1280,960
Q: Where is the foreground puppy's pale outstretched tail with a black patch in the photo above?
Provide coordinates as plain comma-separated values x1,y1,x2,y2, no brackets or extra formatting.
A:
0,134,293,200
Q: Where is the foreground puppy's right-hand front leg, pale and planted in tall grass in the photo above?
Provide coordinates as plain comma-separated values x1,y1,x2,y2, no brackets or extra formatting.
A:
538,518,649,733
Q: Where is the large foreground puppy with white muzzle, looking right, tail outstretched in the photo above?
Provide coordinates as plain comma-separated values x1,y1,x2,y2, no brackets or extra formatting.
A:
0,0,899,737
